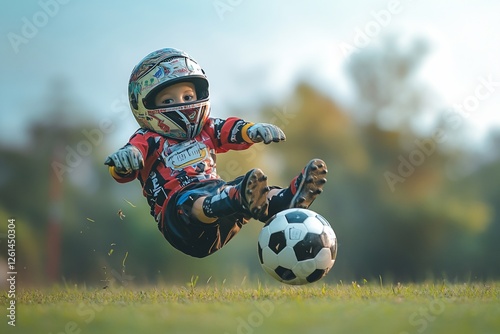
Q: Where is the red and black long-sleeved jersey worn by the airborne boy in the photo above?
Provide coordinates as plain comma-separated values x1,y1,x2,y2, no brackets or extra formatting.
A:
110,117,253,220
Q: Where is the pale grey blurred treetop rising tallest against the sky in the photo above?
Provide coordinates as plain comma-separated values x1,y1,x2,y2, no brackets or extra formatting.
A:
346,34,433,133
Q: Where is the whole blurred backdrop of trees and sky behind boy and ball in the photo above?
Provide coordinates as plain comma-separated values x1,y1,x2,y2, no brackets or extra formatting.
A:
0,0,500,287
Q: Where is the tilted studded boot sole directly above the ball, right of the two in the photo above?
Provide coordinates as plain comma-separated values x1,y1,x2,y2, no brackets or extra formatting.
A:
290,159,328,209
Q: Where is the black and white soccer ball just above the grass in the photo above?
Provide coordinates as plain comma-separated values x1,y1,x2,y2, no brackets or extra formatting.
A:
258,208,337,285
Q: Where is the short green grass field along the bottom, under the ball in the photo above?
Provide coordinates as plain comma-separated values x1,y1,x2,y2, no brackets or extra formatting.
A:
0,280,500,334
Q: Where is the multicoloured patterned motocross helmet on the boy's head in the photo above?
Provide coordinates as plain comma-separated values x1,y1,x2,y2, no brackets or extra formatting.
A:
128,48,210,140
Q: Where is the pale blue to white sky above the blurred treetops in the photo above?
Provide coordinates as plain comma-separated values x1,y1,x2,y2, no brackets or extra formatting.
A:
0,0,500,147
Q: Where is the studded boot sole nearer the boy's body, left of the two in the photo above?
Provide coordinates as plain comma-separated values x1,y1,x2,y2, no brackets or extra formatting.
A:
244,168,270,219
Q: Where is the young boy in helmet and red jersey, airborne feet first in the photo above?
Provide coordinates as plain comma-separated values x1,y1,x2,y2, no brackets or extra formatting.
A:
105,49,327,257
